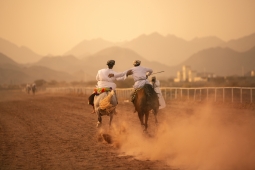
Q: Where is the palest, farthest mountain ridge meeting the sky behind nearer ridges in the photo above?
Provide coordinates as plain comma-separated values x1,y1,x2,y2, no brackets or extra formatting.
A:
65,33,255,66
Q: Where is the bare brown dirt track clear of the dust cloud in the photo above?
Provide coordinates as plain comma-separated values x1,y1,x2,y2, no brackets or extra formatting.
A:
0,92,171,169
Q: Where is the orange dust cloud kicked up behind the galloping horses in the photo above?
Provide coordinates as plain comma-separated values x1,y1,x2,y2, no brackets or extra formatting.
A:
112,105,255,170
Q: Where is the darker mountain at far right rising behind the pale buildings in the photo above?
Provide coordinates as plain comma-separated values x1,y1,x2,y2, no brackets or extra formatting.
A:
176,46,255,76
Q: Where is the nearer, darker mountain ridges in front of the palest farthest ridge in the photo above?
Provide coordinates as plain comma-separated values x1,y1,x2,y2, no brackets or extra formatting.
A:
0,44,255,84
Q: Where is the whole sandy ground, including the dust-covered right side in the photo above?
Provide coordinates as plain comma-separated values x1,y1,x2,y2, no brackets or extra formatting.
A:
0,91,255,170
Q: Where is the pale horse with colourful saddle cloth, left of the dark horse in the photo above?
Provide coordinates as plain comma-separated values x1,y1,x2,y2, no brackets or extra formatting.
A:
94,90,117,127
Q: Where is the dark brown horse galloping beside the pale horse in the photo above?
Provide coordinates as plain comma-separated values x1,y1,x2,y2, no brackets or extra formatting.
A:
132,84,159,132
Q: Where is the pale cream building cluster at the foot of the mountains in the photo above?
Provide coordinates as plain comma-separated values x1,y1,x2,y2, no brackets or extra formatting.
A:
174,65,215,82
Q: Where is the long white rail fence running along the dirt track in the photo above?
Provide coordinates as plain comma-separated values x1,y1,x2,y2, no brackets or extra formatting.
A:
46,87,255,103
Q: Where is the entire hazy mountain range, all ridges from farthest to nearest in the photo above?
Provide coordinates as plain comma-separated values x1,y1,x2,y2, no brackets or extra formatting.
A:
0,33,255,84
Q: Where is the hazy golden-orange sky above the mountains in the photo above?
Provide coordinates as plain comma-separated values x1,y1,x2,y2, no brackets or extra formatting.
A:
0,0,255,55
